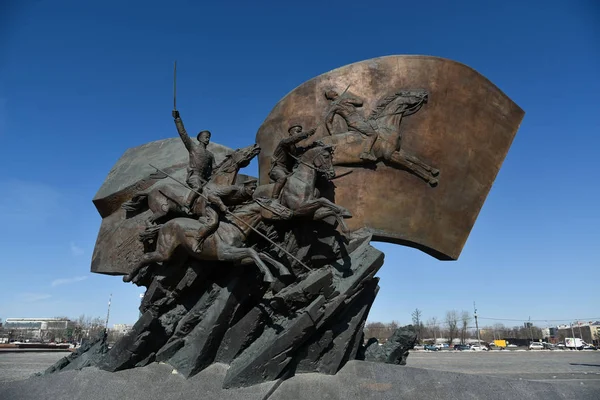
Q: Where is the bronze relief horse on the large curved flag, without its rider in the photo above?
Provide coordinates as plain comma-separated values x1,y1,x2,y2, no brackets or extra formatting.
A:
319,90,440,186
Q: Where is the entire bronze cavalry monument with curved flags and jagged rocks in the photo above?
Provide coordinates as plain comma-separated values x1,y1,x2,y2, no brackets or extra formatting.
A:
69,56,523,388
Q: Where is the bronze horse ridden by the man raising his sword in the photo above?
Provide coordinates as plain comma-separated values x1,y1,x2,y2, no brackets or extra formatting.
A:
122,144,260,225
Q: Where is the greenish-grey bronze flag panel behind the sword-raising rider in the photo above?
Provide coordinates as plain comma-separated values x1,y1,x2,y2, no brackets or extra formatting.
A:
91,138,255,275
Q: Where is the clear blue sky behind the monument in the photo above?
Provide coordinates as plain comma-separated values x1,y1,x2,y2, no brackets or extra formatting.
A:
0,0,600,325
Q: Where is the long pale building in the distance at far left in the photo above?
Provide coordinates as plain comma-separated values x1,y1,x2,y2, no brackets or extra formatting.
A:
4,318,75,340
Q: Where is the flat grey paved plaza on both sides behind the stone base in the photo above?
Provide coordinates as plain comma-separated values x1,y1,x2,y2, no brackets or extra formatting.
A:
0,351,600,388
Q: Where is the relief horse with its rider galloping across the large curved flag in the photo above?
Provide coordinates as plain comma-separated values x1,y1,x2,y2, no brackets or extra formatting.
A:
320,89,440,186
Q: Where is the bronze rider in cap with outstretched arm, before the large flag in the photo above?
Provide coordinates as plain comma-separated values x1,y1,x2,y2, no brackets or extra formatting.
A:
269,125,316,199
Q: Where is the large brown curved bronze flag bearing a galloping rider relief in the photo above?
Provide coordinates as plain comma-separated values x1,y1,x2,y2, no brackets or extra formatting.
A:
256,56,524,260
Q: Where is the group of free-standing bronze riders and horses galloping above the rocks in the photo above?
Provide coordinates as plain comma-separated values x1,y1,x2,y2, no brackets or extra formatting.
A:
123,111,351,283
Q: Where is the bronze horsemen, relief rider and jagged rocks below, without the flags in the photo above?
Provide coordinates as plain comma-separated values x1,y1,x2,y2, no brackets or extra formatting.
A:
77,78,439,387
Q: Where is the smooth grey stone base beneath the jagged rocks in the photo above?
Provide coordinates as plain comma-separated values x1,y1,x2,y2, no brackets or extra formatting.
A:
0,361,600,400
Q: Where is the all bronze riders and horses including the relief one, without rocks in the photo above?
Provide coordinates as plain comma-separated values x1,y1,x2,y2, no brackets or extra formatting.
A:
123,87,439,283
